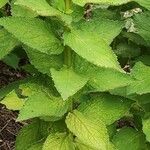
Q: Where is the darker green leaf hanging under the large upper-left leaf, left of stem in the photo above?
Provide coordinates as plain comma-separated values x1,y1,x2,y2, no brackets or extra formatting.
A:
25,48,63,74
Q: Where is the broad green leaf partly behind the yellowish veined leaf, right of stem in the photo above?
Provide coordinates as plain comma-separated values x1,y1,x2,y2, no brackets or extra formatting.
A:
78,94,133,125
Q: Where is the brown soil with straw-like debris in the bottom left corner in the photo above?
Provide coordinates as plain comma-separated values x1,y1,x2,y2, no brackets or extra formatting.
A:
0,105,23,150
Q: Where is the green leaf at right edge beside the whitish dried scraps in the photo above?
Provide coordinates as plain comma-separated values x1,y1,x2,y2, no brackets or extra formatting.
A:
134,11,150,45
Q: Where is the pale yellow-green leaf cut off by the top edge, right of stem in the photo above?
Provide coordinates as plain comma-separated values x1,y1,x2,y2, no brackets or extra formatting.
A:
73,0,131,6
